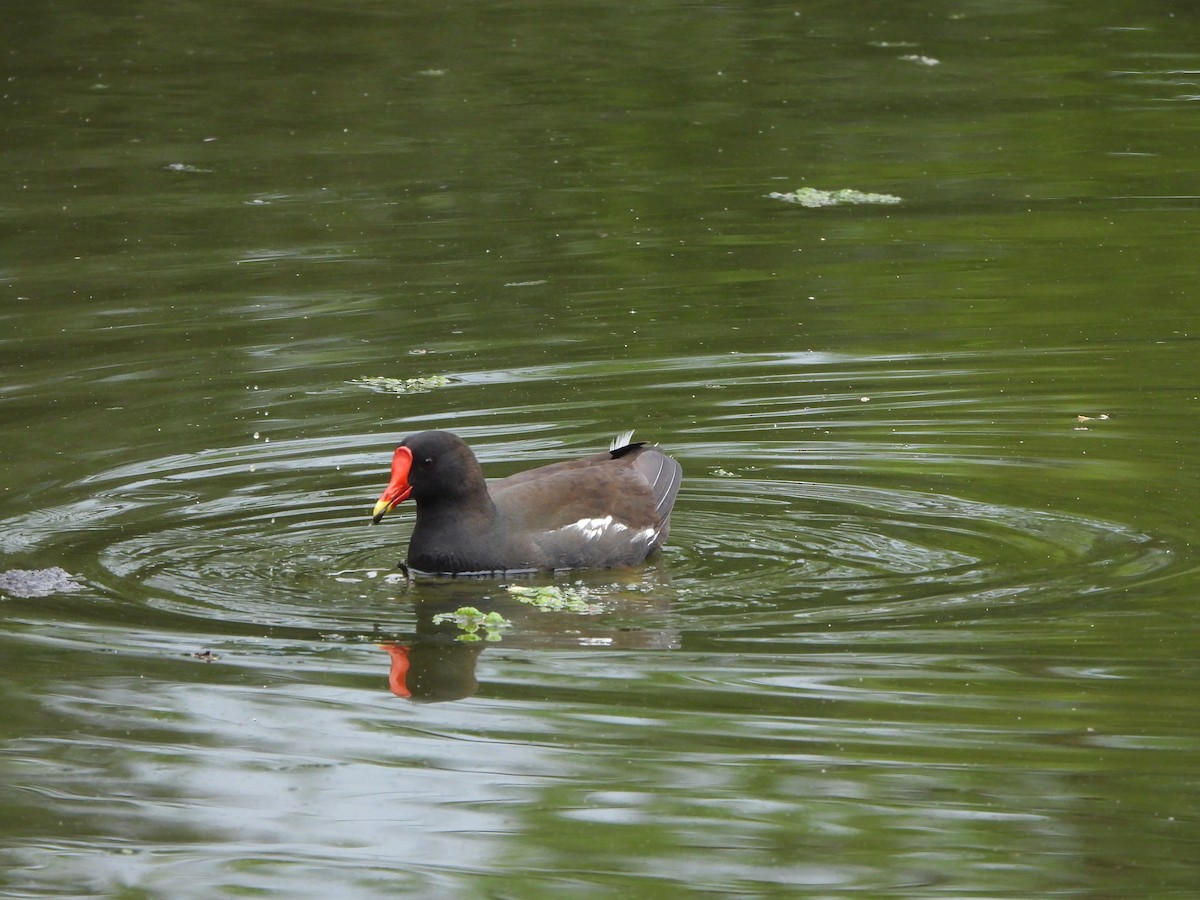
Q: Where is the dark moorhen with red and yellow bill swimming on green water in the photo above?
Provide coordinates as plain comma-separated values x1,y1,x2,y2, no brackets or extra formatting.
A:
374,431,683,574
